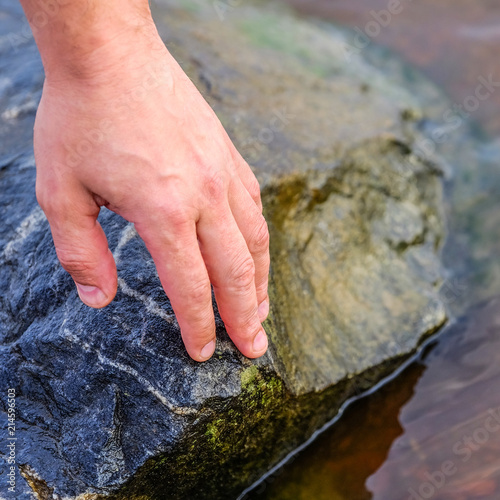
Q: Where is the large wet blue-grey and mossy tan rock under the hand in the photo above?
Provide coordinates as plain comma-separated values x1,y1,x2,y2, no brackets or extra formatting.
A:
0,0,446,500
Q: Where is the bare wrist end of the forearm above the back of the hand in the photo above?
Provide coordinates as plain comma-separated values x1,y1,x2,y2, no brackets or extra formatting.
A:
20,0,157,79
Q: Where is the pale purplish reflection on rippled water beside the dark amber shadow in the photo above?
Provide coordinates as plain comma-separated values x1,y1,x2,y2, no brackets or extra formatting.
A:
366,299,500,500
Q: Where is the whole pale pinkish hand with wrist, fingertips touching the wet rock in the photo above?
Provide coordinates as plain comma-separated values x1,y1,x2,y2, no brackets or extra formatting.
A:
21,0,269,361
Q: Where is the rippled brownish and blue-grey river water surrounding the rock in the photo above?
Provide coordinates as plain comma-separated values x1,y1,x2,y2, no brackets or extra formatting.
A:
247,0,500,500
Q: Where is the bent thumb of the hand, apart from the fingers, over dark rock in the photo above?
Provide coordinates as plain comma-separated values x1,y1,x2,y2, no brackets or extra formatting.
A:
37,186,117,308
